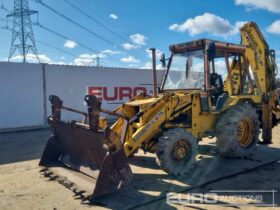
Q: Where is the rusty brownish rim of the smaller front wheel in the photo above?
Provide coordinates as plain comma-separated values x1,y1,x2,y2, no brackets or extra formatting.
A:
172,139,191,162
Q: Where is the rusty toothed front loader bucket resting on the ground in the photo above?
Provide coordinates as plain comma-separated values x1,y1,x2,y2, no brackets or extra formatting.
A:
39,96,132,198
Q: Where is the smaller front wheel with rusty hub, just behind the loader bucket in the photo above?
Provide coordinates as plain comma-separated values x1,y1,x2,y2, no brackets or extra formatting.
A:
156,128,198,175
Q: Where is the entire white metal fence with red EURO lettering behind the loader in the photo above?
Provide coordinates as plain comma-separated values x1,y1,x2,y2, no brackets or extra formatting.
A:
0,62,163,132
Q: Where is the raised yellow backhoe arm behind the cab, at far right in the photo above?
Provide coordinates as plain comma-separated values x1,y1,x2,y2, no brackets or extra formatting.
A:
240,22,276,144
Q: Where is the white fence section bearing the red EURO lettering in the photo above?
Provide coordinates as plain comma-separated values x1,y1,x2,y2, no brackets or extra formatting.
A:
45,65,163,120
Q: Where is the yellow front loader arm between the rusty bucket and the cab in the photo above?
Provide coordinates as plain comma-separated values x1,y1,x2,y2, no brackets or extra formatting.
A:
111,93,192,156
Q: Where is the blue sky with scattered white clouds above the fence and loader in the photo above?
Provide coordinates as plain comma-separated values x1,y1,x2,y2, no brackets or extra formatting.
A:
0,0,280,68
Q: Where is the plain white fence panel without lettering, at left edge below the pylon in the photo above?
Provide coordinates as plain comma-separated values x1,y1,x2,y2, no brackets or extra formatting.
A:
0,62,44,130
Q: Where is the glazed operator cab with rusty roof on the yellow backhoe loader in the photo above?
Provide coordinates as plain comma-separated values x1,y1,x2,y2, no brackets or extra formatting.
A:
161,39,248,111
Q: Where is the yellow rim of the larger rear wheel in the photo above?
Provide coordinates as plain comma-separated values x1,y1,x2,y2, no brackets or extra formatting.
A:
237,117,254,147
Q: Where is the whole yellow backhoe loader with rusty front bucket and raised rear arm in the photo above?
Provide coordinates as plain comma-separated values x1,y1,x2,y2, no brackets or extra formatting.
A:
39,22,280,199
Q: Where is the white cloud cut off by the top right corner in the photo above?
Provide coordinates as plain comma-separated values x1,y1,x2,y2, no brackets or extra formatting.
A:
235,0,280,13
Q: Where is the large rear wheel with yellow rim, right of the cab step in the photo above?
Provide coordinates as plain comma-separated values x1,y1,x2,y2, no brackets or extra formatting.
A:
216,103,260,158
